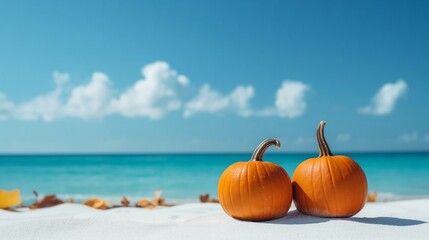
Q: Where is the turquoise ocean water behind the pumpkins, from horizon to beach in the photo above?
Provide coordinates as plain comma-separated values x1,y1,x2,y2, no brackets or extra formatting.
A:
0,152,429,204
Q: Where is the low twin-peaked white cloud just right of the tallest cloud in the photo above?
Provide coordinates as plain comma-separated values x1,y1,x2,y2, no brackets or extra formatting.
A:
183,84,254,118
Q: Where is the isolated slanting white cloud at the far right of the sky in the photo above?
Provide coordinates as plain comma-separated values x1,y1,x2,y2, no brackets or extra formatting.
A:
358,79,408,115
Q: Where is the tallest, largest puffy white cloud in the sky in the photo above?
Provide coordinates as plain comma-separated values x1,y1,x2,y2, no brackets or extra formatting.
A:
109,62,189,119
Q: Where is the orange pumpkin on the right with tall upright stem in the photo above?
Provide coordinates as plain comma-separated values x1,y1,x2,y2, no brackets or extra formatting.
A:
292,121,368,217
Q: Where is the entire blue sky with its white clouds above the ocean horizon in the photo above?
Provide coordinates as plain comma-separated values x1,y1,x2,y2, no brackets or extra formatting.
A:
0,1,429,153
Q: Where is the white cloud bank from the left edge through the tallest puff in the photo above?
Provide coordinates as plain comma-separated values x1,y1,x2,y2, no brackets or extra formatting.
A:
0,62,189,122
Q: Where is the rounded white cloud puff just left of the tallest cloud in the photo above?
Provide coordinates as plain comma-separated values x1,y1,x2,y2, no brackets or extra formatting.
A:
63,72,113,118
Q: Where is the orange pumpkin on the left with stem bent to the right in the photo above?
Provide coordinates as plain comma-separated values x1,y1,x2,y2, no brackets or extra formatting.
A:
218,139,292,221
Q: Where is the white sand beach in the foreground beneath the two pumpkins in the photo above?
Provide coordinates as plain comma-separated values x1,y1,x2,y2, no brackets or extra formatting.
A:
0,199,429,240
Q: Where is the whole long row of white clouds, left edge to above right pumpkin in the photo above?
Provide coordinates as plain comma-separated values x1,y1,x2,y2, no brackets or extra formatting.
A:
0,61,309,122
